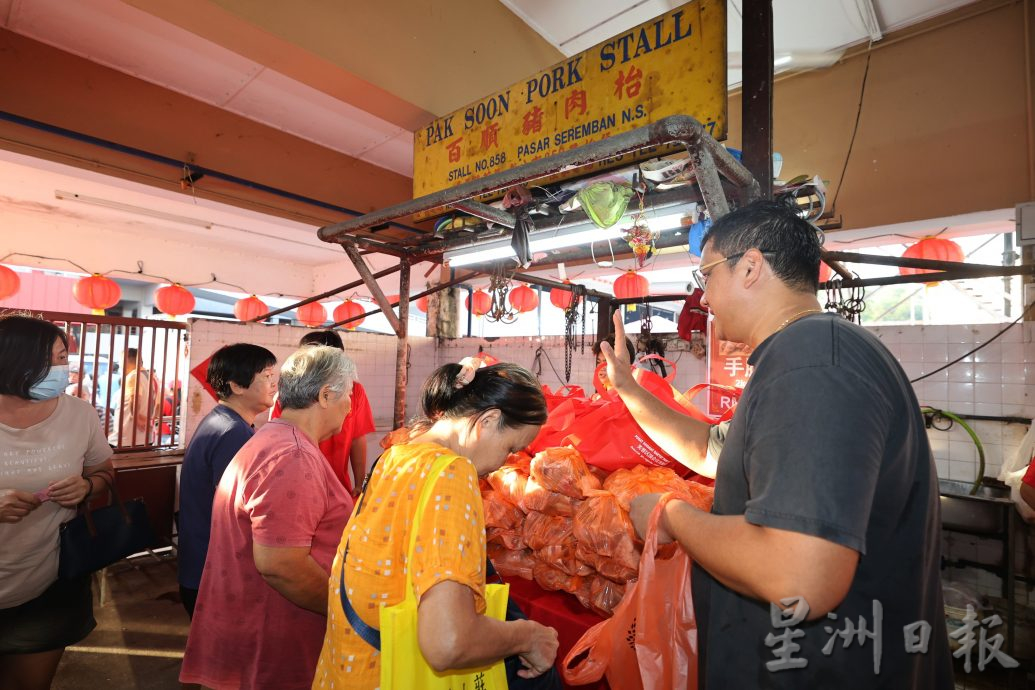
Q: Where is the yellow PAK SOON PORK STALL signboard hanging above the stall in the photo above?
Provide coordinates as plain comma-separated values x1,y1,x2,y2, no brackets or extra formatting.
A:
413,0,727,198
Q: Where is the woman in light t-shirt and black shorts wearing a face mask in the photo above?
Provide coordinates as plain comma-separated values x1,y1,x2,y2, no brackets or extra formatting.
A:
0,314,112,690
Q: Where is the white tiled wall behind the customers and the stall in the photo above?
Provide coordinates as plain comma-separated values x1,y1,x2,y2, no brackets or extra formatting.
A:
186,320,1035,481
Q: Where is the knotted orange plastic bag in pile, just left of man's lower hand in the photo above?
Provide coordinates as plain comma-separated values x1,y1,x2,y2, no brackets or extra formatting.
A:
573,491,640,579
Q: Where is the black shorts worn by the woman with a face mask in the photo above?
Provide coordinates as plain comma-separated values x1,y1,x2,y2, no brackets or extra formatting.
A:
0,575,97,655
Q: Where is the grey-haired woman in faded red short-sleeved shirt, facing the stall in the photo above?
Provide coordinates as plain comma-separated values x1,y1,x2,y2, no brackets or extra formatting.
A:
180,347,356,690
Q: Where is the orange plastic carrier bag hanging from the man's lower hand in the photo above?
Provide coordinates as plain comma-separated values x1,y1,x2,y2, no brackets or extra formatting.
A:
561,494,698,690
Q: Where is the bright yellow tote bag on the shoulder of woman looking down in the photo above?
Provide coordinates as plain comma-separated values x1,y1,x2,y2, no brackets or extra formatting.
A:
380,455,510,690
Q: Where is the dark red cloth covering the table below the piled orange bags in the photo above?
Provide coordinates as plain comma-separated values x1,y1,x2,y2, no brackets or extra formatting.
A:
503,577,611,690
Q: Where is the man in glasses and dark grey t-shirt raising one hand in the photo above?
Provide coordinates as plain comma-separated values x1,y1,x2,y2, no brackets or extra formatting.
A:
604,202,953,690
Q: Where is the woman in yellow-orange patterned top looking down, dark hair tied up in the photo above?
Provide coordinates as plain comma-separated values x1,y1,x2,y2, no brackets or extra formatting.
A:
313,364,557,690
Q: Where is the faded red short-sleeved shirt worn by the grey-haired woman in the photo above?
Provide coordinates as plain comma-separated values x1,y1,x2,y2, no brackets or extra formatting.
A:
180,421,352,690
